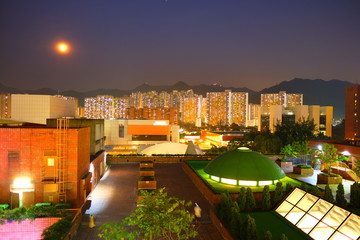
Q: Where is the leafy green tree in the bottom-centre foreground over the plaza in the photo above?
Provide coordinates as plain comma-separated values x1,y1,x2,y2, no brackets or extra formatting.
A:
99,188,198,240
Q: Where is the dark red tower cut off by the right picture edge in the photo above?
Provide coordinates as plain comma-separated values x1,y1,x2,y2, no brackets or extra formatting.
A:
345,85,360,140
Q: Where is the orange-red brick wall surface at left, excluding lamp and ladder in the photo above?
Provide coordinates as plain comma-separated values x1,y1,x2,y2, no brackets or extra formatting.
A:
0,127,90,207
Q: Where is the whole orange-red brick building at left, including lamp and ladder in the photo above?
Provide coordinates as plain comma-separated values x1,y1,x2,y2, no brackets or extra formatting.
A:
0,127,92,207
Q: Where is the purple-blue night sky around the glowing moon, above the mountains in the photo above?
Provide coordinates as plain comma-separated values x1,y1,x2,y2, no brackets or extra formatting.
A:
0,0,360,91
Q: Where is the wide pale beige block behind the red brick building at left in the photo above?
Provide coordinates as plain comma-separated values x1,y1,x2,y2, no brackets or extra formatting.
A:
0,94,78,124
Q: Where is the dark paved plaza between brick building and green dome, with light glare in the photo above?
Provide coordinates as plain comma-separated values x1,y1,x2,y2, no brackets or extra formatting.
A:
75,163,222,240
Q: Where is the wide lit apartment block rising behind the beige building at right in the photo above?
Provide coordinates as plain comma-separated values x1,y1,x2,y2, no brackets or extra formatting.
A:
261,91,303,114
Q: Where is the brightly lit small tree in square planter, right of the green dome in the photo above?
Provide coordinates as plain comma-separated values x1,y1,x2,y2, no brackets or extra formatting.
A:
315,143,349,184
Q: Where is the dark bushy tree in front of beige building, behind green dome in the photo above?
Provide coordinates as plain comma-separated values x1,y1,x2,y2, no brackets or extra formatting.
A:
275,119,316,146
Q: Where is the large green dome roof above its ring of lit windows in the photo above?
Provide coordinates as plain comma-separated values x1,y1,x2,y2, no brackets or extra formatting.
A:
204,148,285,181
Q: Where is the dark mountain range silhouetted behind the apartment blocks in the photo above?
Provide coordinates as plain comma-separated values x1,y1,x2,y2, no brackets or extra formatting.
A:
0,78,354,119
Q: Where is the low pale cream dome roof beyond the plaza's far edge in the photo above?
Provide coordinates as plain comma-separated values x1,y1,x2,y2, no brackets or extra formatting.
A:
138,142,203,155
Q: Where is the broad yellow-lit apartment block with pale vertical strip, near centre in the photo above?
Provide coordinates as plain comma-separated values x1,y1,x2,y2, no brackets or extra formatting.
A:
207,90,248,126
